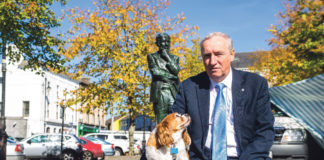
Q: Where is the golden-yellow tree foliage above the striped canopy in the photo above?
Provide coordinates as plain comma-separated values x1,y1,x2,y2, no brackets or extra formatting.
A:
252,0,324,85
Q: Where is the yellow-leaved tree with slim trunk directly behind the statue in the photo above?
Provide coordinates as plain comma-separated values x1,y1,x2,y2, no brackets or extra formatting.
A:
62,0,194,155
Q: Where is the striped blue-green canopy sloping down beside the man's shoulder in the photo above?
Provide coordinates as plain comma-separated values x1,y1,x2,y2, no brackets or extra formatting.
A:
269,74,324,149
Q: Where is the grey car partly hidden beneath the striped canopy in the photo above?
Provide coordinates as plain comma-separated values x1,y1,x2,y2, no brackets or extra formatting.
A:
270,106,308,160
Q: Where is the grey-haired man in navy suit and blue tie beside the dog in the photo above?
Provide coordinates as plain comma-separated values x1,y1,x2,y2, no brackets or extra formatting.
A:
172,32,274,160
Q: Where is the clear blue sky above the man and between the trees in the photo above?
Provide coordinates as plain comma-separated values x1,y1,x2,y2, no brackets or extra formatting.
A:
54,0,284,53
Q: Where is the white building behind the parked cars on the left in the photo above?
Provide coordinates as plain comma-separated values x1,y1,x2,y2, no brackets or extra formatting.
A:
0,59,79,138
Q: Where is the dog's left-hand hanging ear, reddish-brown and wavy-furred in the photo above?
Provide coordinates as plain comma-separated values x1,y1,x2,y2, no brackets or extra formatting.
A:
156,121,173,146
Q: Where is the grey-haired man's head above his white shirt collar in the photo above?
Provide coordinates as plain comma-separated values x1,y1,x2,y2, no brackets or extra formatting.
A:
201,37,235,82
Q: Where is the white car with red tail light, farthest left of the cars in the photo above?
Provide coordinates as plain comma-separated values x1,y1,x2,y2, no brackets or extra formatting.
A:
6,139,25,160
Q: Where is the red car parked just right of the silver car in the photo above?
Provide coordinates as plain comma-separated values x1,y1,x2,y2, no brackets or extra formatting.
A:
79,137,104,160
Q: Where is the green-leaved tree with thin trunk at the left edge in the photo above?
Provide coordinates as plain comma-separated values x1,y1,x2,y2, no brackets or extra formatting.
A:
0,0,65,159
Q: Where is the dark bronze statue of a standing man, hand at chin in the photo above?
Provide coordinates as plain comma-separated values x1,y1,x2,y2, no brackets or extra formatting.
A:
147,33,180,123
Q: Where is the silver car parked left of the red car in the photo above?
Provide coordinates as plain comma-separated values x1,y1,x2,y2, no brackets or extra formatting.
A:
20,133,83,160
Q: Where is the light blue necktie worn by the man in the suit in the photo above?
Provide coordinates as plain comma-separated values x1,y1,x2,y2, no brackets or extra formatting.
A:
211,83,227,160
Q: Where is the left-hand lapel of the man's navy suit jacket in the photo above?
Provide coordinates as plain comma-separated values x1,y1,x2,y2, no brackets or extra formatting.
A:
196,72,210,142
